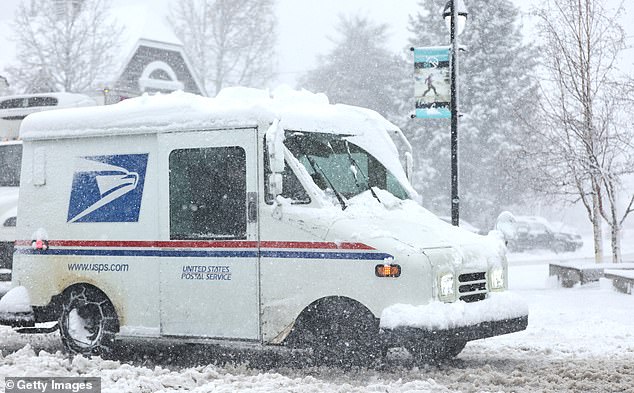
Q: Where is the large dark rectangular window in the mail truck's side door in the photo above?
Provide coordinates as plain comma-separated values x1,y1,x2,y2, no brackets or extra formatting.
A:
169,146,247,239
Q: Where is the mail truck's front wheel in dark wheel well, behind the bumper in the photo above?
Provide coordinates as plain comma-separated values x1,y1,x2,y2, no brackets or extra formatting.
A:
289,300,385,368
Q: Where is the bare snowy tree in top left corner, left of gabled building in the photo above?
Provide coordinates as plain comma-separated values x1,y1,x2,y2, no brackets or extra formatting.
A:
7,0,122,92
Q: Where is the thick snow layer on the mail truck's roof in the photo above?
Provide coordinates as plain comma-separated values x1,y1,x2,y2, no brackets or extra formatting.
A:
20,87,398,142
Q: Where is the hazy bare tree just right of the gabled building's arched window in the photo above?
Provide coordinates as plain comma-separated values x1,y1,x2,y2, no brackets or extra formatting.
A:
168,0,276,94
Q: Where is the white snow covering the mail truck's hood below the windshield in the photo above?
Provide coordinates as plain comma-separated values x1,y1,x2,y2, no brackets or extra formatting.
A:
283,188,506,267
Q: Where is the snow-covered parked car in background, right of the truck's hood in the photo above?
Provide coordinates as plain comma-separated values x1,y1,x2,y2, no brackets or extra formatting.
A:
507,216,583,253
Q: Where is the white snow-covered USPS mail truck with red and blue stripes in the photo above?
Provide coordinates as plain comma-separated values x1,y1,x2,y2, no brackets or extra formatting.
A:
0,88,528,364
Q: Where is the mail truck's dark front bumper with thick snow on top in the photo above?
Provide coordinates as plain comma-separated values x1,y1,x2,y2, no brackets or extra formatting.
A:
381,292,528,345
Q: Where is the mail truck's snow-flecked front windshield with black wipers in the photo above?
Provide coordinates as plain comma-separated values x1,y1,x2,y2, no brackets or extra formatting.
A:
284,132,408,199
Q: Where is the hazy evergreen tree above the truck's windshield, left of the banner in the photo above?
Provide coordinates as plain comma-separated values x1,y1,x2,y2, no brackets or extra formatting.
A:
299,16,409,117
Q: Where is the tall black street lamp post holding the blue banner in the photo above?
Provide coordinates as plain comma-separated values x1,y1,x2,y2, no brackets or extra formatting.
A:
442,0,467,226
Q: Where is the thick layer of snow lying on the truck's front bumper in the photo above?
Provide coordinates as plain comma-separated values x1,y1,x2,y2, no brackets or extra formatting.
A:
381,292,528,330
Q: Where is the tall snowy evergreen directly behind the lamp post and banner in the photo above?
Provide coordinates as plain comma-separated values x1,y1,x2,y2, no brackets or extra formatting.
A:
401,0,537,228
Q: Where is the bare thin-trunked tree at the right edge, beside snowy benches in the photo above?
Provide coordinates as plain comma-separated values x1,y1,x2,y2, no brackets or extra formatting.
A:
525,0,634,263
